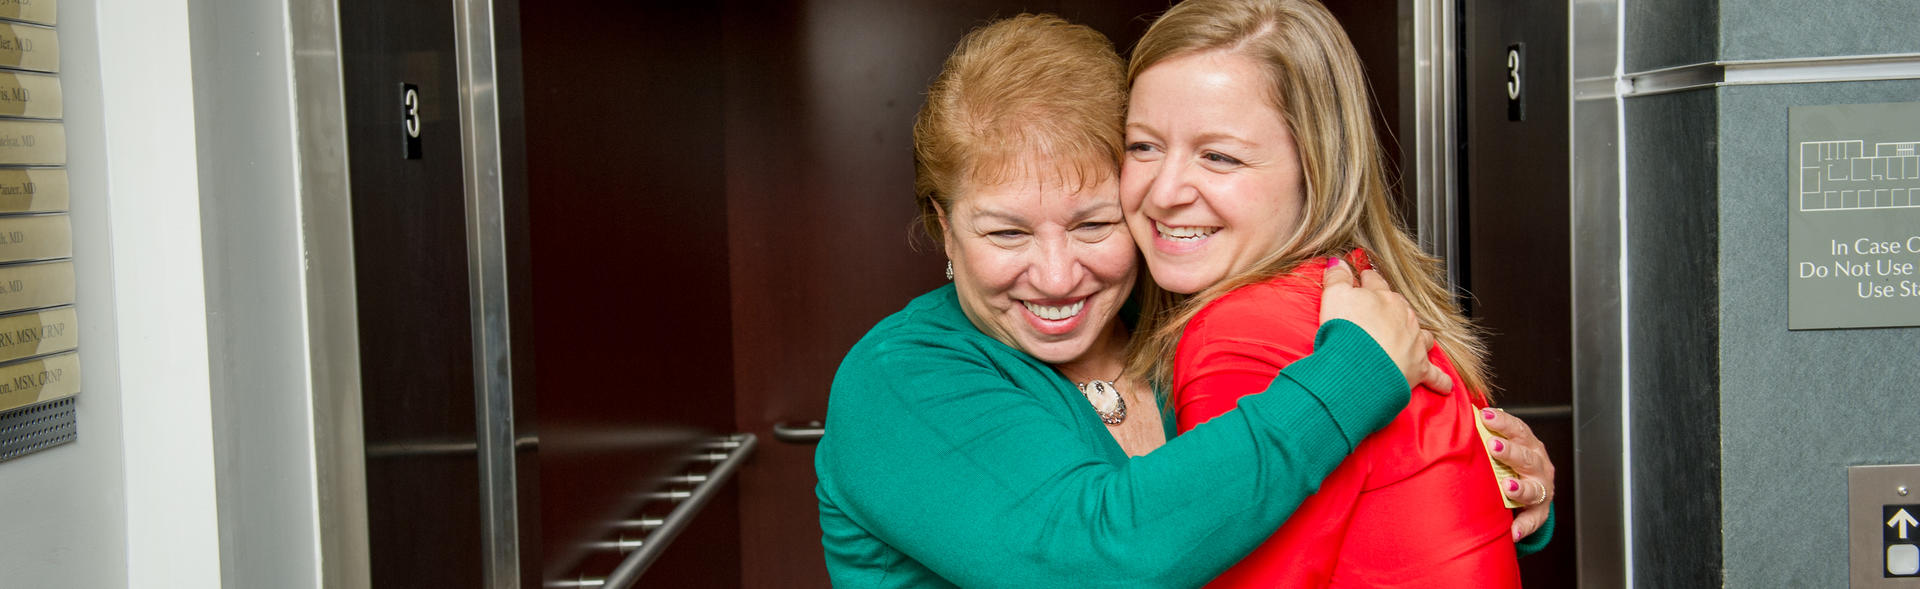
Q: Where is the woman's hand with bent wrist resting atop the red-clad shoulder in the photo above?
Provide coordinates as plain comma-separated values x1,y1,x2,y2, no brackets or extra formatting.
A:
1321,259,1453,393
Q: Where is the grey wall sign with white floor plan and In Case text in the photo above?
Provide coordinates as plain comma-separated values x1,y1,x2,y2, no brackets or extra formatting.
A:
1786,102,1920,330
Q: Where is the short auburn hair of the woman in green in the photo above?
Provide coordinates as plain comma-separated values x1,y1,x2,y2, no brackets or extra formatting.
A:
914,13,1127,242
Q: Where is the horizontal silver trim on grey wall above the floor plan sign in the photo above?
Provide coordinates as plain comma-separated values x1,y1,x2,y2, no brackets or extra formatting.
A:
1624,54,1920,96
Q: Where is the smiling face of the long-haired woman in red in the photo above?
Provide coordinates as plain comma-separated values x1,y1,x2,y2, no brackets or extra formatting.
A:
1119,50,1306,294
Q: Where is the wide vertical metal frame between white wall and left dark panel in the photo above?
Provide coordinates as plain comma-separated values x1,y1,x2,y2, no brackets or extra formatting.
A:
286,0,372,587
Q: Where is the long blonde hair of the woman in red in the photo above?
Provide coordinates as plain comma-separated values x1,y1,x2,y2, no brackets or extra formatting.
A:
1127,0,1488,397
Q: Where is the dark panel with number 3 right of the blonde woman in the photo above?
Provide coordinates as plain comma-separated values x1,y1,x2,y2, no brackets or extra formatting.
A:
1448,0,1580,585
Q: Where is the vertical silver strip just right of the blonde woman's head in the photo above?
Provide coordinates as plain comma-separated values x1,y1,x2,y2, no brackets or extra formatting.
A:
1402,0,1459,288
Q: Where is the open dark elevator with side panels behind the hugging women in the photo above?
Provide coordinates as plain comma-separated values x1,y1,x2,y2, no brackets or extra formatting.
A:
330,0,1574,587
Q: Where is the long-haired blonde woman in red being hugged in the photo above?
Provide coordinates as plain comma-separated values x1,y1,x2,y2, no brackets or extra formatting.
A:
1121,0,1551,587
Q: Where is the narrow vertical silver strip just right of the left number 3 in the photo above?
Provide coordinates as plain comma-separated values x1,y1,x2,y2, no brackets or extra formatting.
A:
453,0,520,589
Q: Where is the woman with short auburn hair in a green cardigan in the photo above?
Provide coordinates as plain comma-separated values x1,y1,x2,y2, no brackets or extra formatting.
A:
814,15,1434,587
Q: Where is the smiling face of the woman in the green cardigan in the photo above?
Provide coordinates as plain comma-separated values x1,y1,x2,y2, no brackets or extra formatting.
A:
941,175,1135,365
